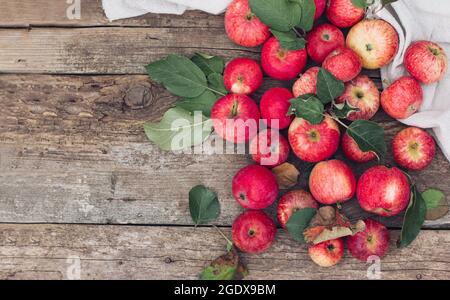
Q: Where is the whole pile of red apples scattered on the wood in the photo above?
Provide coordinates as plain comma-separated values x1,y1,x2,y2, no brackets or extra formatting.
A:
216,0,447,267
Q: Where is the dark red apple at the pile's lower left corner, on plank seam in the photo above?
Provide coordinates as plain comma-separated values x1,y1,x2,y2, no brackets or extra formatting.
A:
231,210,277,253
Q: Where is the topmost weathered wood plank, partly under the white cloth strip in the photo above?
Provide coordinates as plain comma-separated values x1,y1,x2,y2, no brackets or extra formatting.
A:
0,0,223,28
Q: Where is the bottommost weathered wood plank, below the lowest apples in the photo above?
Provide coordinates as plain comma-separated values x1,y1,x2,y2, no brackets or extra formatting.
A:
0,224,450,279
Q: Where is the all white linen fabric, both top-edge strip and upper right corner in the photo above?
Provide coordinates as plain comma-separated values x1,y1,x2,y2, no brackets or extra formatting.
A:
102,0,450,160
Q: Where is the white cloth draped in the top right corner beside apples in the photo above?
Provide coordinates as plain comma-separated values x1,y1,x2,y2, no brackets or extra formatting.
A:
377,0,450,160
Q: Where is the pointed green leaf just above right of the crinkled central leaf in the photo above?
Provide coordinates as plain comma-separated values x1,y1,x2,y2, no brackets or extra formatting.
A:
317,68,345,104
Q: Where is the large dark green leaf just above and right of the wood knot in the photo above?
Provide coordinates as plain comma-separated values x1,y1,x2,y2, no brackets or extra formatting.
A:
146,54,208,98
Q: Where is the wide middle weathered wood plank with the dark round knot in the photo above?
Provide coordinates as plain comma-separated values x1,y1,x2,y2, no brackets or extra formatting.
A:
0,75,450,228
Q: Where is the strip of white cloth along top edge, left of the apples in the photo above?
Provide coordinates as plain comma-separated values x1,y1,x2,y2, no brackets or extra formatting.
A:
102,0,231,21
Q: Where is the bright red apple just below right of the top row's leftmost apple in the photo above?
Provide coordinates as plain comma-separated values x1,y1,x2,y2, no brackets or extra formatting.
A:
261,37,307,80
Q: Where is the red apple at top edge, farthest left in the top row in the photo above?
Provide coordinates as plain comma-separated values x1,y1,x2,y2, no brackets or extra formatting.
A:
225,0,270,47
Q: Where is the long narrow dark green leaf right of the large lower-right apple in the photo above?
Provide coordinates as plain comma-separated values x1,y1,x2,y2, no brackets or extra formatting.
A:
397,186,427,248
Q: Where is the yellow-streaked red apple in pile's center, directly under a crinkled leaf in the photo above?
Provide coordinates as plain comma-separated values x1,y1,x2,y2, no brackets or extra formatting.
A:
288,116,340,162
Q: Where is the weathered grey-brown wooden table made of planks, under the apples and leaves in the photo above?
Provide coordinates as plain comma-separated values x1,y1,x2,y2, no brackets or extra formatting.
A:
0,0,450,279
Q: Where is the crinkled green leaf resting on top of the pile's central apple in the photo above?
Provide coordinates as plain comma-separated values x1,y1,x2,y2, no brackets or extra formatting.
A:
289,94,325,124
